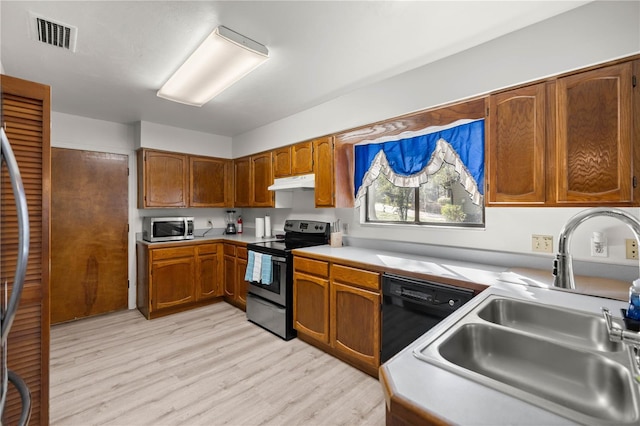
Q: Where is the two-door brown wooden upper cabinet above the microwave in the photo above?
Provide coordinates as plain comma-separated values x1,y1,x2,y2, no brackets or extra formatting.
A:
138,148,233,208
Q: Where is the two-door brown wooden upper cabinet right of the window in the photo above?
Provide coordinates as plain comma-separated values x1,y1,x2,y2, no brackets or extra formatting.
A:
487,61,640,206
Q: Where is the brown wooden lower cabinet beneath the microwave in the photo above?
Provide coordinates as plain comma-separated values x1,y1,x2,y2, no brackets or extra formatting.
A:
136,242,224,319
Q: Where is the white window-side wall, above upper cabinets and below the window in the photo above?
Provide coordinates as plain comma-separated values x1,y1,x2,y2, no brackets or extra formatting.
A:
228,1,640,264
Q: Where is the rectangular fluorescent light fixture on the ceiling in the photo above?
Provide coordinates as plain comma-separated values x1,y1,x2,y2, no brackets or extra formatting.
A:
157,26,269,106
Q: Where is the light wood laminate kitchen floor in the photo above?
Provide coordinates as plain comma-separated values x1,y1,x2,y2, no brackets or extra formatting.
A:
50,302,384,425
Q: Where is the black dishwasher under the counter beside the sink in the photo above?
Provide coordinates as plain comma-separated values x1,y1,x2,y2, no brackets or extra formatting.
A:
380,274,473,362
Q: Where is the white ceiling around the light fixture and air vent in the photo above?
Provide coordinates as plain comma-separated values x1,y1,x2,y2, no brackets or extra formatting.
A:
0,0,588,136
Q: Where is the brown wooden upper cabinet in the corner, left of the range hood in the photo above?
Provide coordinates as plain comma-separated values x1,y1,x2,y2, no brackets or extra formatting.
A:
234,151,275,207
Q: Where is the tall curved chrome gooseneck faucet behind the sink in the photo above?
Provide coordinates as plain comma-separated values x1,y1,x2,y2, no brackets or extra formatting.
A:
553,207,640,289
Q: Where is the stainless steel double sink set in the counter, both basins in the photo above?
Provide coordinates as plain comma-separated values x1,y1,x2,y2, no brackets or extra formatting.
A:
414,295,640,425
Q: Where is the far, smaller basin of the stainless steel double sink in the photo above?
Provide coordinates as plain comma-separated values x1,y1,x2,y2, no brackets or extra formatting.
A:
478,298,624,352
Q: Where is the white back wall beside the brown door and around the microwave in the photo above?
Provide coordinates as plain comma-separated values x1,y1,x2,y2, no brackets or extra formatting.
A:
51,112,231,309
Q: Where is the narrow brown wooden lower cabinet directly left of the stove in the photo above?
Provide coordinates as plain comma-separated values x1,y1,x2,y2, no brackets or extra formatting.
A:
224,243,248,310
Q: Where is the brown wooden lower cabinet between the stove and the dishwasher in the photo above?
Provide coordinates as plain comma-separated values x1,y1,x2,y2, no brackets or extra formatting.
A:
293,256,381,377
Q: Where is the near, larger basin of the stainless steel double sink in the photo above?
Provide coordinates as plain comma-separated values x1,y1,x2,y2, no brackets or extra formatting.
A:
439,324,637,423
